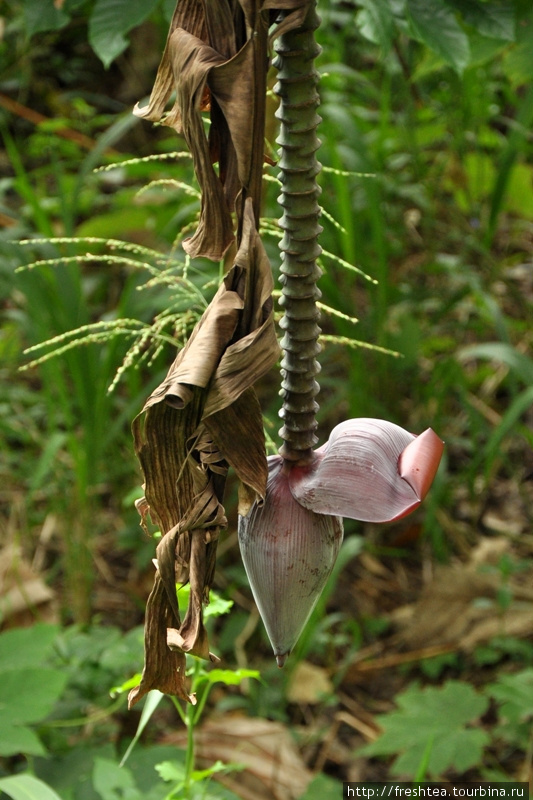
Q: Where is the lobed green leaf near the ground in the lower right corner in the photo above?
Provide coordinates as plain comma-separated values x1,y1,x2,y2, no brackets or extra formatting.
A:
359,681,489,777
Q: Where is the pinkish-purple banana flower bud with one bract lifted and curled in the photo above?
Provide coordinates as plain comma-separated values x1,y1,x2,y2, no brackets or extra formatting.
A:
239,419,444,666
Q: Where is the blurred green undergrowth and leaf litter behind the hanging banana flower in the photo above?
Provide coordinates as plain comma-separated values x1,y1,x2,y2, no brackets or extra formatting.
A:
0,0,533,800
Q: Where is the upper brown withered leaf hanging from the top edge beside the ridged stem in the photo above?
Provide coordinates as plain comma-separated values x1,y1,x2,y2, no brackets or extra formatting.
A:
134,0,309,261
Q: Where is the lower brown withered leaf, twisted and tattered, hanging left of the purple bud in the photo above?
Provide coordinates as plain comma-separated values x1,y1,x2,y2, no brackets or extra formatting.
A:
132,199,279,702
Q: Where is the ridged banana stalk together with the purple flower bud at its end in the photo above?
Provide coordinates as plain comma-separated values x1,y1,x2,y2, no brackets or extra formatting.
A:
239,2,443,667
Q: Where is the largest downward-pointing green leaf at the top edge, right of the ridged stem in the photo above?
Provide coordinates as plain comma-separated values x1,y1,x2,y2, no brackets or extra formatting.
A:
407,0,470,73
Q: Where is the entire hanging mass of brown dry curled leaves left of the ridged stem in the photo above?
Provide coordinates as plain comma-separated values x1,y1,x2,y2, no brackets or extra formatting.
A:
130,0,320,705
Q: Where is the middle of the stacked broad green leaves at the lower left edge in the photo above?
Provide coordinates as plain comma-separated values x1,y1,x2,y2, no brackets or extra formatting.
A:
0,667,68,725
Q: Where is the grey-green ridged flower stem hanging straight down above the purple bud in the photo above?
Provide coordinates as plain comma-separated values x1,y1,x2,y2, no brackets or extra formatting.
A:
274,2,322,464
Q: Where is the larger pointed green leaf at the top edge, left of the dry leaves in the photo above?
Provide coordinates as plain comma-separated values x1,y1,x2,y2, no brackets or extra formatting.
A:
89,0,158,67
